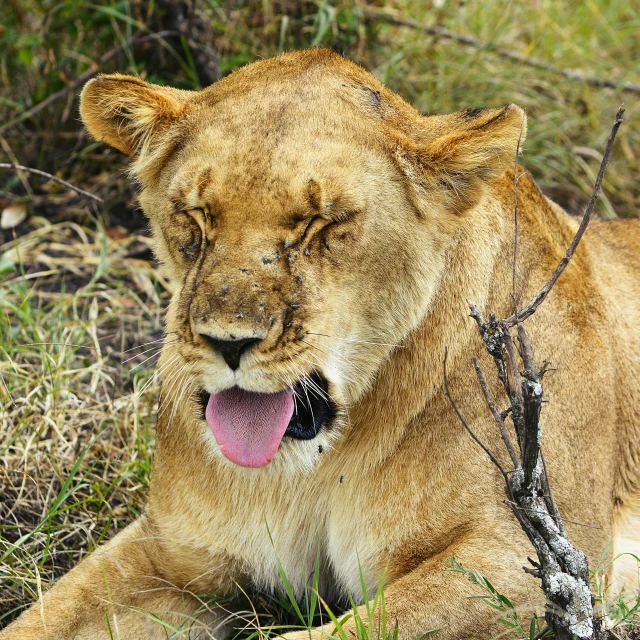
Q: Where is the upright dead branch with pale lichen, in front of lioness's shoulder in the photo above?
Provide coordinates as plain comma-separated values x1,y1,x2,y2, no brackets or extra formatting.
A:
443,107,624,640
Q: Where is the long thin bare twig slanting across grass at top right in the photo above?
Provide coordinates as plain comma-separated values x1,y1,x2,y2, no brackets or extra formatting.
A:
364,9,640,93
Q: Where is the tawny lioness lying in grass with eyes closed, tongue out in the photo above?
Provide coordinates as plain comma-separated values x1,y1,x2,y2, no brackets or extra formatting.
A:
0,49,640,640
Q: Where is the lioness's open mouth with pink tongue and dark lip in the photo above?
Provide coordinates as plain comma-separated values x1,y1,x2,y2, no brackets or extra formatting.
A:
201,371,335,467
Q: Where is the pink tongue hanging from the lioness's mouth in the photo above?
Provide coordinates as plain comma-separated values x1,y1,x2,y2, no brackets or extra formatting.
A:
205,387,293,467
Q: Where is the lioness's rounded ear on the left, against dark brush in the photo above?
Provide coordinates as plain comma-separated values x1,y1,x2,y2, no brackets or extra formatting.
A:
80,73,188,156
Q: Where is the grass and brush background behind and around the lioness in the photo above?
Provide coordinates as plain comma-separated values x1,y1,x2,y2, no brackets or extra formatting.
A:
0,0,640,627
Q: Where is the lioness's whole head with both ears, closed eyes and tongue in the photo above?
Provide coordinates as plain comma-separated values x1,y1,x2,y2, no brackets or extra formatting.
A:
82,51,520,467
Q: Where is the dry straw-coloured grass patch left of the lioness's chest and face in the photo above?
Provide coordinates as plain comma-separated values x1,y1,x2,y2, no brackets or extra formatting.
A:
0,218,168,619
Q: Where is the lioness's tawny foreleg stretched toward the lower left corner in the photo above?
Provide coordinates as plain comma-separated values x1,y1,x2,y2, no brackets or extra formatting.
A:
0,517,222,640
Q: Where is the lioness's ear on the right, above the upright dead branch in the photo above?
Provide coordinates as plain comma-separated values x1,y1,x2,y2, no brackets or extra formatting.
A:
395,104,527,213
